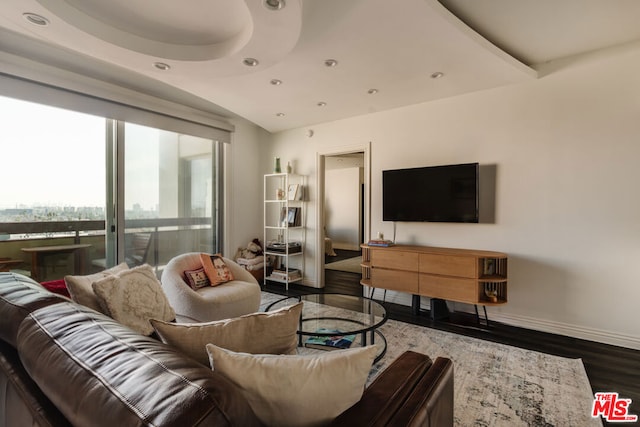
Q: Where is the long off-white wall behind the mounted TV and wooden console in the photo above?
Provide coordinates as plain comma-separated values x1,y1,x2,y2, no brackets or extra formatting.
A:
265,47,640,349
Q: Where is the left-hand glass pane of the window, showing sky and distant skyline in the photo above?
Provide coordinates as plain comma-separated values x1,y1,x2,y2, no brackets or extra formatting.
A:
0,97,106,281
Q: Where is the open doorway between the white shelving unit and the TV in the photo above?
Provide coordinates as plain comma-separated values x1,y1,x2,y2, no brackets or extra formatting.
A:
316,144,370,292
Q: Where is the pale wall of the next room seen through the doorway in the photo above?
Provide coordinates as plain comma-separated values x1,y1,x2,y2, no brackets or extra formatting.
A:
324,167,361,251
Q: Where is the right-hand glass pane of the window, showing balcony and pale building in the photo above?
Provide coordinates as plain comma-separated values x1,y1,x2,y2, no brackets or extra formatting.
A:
121,123,219,274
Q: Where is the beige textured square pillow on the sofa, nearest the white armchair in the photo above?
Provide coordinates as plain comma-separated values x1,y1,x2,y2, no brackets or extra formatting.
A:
93,264,176,335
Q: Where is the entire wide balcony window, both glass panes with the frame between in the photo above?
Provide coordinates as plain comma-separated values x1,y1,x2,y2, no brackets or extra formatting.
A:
0,96,220,281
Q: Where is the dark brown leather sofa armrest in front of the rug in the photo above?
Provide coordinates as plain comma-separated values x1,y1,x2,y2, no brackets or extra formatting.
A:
332,351,453,427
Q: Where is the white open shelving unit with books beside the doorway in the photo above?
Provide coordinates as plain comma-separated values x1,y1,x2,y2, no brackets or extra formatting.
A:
263,173,306,290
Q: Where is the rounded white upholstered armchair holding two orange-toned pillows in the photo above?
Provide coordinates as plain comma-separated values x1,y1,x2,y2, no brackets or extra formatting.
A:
160,252,260,322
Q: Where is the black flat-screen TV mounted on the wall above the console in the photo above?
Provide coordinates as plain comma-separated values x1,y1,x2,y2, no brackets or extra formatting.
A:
382,163,479,222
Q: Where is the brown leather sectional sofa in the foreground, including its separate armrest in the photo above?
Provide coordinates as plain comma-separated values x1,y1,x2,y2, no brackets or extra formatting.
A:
0,273,453,427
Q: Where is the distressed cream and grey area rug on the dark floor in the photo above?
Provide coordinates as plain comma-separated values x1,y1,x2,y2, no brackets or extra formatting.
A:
262,292,602,427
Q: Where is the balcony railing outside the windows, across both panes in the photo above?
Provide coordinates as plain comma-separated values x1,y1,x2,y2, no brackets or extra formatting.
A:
0,217,215,280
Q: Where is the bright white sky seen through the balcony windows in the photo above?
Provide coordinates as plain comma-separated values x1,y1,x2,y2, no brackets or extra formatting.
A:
0,97,158,209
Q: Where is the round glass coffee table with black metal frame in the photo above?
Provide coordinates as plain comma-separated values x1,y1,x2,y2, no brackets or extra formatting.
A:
266,294,387,362
